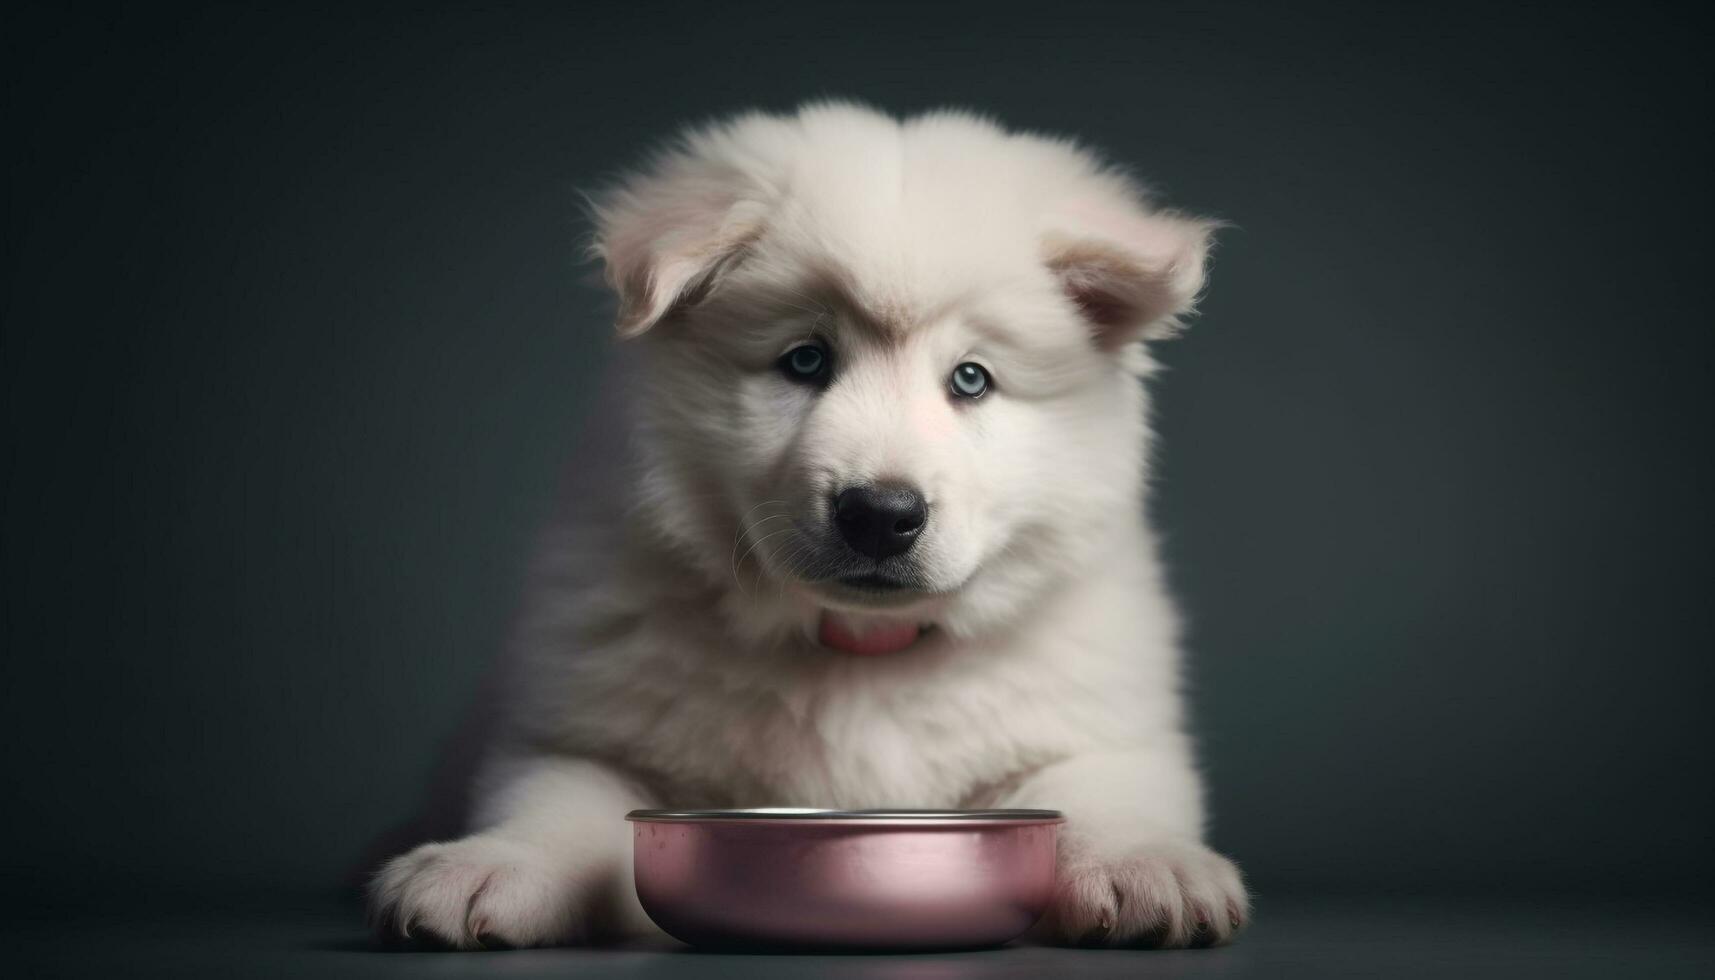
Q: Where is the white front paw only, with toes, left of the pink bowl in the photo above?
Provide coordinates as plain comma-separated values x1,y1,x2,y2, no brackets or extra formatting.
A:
369,836,617,949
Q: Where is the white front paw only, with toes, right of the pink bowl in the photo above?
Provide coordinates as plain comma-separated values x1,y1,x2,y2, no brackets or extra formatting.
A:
1043,843,1250,947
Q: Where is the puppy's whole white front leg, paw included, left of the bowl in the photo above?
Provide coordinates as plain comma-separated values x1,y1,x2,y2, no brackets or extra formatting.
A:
369,757,653,949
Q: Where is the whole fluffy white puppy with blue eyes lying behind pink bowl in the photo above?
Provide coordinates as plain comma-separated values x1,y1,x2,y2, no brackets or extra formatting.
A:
370,105,1247,947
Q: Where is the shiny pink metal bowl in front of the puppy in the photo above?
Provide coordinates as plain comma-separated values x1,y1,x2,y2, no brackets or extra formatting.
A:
626,808,1065,949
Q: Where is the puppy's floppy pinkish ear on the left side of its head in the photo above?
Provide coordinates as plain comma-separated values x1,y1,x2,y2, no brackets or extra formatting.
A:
590,163,761,338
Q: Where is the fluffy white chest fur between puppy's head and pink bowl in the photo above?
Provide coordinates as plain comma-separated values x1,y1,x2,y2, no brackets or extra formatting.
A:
500,511,1180,807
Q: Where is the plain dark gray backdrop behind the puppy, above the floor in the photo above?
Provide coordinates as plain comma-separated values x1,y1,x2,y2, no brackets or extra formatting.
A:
0,2,1715,947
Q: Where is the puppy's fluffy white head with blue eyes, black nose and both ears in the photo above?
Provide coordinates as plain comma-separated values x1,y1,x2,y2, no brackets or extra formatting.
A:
595,105,1213,652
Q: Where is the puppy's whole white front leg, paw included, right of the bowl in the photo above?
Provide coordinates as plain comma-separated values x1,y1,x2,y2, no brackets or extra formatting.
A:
1003,745,1250,947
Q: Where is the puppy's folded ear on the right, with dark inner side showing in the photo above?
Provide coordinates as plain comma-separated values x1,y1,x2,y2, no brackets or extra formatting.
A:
1043,201,1221,350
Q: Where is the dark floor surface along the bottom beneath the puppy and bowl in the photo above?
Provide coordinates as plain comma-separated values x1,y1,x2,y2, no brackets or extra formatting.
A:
5,898,1715,980
